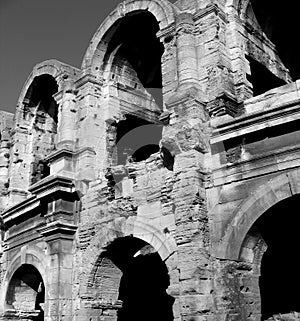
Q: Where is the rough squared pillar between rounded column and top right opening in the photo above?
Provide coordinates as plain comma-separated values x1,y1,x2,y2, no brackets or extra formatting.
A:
194,1,238,117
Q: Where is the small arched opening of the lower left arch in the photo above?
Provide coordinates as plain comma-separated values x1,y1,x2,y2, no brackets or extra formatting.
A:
6,264,45,321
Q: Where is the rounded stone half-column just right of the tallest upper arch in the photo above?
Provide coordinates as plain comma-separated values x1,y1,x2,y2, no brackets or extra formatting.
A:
176,13,199,88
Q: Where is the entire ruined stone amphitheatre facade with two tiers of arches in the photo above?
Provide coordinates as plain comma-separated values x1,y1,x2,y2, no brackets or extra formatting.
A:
0,0,300,321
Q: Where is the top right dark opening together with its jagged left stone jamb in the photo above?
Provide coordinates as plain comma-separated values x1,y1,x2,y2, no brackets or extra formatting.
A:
225,0,300,102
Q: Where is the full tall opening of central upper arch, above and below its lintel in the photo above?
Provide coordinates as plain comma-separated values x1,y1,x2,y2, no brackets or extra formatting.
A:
102,10,164,164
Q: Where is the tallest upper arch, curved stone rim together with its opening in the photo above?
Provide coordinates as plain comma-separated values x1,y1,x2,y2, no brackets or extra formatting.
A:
79,0,175,165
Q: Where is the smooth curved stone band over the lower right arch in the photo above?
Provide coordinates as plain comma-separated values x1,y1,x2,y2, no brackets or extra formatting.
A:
214,170,300,260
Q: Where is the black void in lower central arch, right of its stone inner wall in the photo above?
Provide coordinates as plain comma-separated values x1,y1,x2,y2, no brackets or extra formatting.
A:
118,242,173,321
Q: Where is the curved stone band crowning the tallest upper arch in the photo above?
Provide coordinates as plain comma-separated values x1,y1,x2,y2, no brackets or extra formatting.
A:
81,0,176,69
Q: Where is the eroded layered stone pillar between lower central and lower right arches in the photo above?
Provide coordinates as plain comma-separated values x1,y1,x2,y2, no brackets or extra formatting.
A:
161,88,213,321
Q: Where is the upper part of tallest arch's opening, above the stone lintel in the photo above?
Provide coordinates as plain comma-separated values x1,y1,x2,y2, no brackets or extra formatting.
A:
99,10,164,99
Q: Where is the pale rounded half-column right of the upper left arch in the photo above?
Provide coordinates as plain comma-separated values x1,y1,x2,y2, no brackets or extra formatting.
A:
55,81,76,150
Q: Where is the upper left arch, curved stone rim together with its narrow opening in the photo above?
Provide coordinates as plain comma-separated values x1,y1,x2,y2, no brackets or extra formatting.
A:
10,60,78,191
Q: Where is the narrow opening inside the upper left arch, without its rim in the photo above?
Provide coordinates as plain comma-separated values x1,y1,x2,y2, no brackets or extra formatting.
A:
23,74,58,184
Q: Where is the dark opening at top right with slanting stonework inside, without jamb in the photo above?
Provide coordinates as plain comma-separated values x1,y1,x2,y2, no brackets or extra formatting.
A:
245,0,300,96
